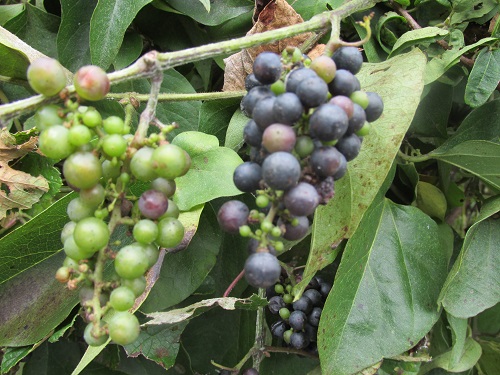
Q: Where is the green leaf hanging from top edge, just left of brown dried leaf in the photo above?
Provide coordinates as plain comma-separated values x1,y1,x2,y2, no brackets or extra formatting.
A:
157,0,253,26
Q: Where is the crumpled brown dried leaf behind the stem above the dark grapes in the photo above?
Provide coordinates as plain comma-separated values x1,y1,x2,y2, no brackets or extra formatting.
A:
223,0,311,91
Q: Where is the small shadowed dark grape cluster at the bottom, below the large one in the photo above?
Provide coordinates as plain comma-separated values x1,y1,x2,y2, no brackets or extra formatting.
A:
266,276,332,353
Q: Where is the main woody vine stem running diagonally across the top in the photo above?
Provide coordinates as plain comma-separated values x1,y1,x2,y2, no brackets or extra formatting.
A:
0,0,382,126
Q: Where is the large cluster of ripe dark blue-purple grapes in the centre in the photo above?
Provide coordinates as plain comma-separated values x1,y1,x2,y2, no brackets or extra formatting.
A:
218,46,383,288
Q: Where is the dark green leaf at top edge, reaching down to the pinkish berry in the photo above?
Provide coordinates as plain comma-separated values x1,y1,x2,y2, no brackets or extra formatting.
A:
57,0,97,72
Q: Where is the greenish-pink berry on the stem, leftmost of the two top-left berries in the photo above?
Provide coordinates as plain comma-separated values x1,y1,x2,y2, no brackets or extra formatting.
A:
26,57,66,96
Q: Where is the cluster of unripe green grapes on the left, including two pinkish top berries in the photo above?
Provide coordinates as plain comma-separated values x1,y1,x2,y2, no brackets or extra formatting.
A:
28,59,191,345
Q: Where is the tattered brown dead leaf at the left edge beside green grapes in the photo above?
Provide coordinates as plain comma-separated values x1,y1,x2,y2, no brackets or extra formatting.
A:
0,129,49,220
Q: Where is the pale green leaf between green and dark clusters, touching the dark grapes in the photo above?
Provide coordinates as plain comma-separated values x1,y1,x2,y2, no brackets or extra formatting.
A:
174,147,242,210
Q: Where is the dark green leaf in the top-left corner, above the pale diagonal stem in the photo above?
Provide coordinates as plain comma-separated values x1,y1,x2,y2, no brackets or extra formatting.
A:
4,3,61,58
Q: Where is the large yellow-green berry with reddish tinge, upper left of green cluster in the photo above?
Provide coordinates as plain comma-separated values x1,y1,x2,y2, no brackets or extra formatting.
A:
63,152,102,189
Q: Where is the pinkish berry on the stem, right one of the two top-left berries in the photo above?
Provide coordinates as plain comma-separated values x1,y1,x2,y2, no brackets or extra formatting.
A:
73,65,110,101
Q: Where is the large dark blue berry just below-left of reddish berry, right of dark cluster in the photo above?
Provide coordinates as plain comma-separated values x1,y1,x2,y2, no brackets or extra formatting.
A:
309,103,349,142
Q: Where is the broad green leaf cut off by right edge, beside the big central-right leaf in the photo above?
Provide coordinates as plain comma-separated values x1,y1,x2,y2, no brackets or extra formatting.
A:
439,197,500,318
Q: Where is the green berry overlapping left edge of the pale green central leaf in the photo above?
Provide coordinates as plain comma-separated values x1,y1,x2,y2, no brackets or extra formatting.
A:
152,143,191,180
